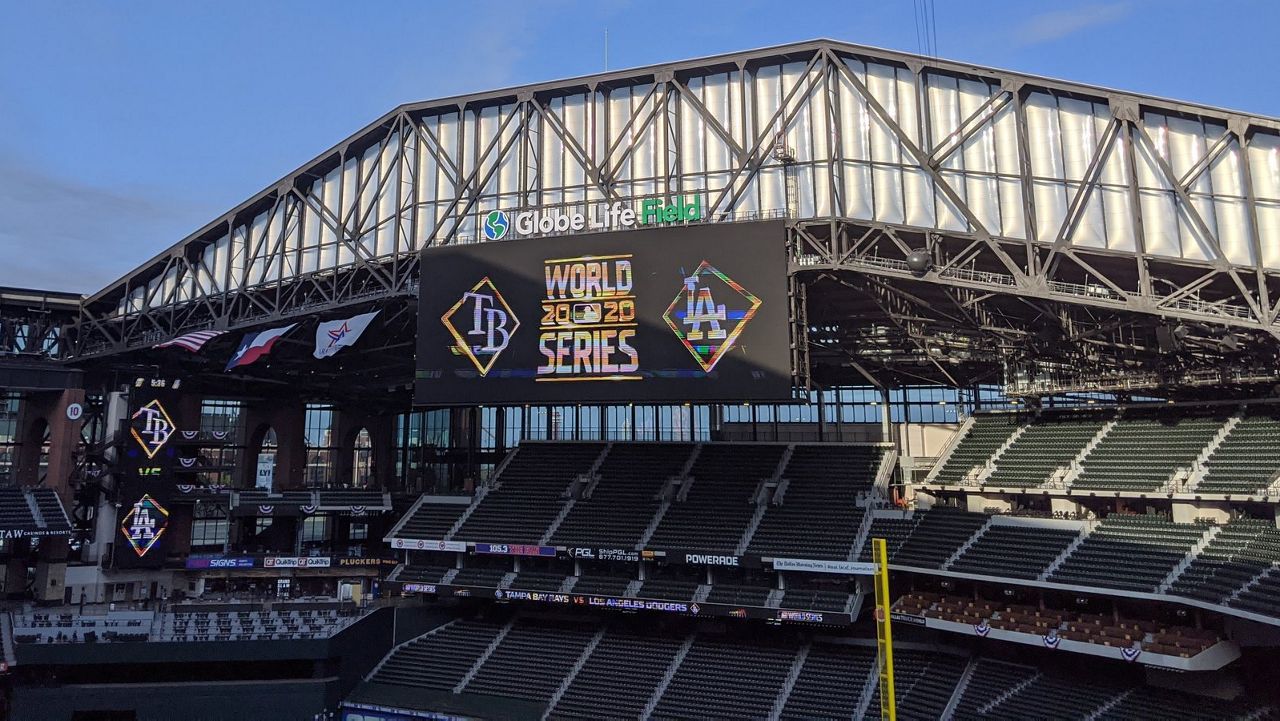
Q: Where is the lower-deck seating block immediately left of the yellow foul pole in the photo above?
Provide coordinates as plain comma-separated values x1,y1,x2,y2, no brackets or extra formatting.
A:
781,643,876,720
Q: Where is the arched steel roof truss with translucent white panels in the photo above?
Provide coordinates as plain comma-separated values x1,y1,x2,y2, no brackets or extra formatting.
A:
72,40,1280,394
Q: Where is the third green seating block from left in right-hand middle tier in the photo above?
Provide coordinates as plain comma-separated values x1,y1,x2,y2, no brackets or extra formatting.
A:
1048,515,1206,593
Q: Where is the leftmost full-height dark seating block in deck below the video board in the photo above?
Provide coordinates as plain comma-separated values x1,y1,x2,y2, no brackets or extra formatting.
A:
452,443,604,543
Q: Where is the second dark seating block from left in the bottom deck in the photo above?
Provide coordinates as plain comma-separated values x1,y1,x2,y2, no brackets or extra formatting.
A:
463,621,593,702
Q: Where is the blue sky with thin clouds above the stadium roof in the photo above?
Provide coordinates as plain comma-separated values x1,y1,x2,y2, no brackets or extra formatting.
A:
0,0,1280,292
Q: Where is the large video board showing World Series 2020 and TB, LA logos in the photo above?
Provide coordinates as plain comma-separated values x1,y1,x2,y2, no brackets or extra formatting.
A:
415,218,791,406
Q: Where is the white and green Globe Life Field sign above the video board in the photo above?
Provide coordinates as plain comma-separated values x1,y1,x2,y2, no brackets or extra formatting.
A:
483,192,705,241
